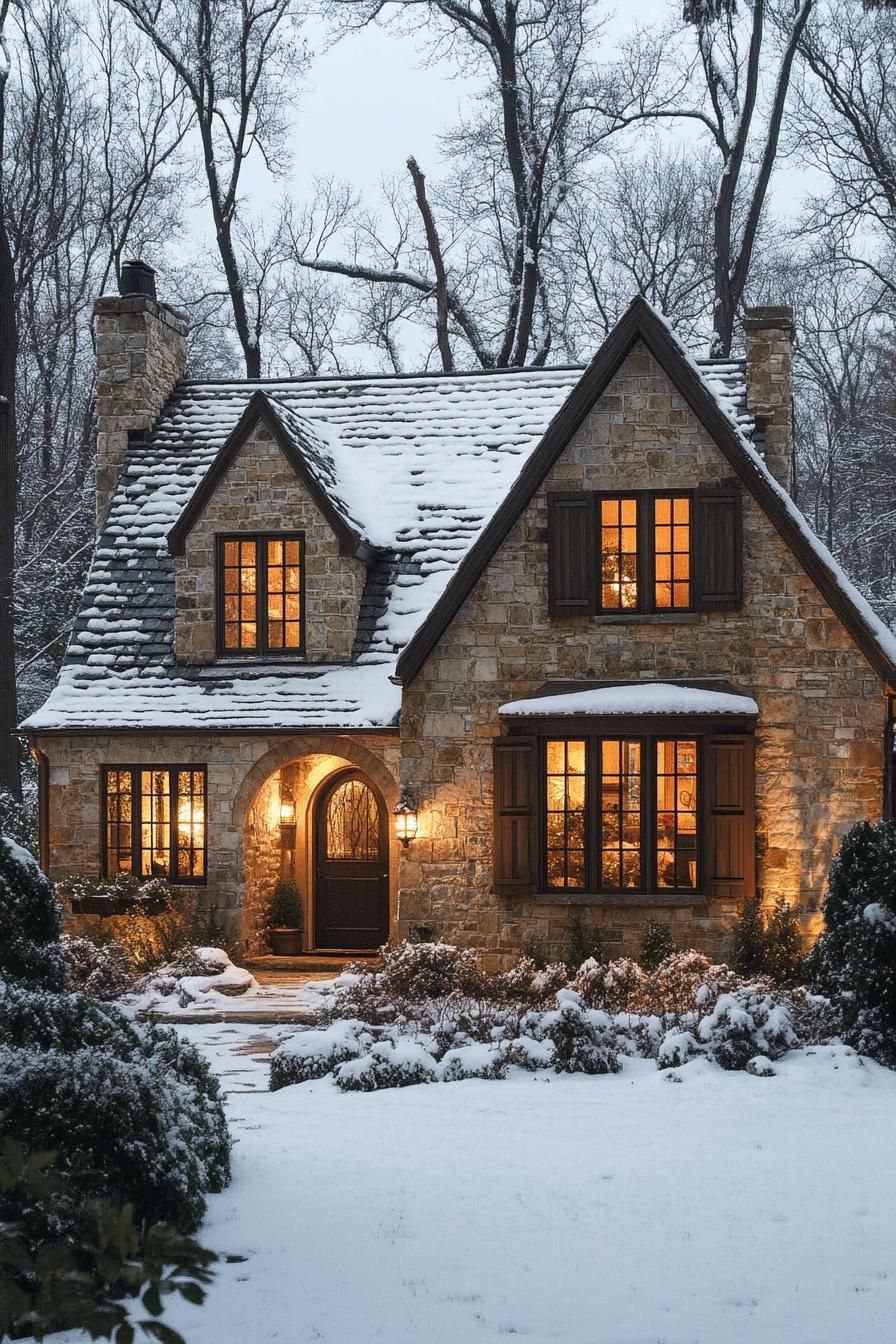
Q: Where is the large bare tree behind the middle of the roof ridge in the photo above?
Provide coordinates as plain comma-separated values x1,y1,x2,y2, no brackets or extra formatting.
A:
292,0,617,368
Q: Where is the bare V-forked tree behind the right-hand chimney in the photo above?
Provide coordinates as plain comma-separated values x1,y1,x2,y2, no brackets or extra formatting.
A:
602,0,815,356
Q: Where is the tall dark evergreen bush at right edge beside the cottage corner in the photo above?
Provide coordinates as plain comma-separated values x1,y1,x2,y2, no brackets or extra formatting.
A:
809,821,896,1066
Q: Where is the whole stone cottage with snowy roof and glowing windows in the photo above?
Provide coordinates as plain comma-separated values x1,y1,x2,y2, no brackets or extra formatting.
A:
24,265,896,961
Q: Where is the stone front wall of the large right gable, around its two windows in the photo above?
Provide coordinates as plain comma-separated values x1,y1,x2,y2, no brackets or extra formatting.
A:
400,347,885,960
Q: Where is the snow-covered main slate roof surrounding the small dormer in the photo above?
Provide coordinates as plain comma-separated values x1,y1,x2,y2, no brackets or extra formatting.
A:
24,341,752,730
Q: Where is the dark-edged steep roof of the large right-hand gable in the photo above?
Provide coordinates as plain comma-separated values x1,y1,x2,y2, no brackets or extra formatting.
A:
396,296,896,685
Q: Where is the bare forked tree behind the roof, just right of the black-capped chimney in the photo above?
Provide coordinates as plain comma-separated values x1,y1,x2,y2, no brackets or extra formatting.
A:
116,0,305,378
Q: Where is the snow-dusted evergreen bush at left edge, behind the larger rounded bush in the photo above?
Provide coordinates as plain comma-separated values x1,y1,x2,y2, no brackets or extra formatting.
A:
0,836,66,989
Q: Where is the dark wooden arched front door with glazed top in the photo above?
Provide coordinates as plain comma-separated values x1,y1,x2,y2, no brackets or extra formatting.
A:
314,770,388,952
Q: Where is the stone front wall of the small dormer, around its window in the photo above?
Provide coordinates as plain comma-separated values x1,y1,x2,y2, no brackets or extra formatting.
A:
175,423,367,664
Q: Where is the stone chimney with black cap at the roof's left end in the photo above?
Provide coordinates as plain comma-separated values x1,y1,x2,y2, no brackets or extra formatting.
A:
93,261,187,531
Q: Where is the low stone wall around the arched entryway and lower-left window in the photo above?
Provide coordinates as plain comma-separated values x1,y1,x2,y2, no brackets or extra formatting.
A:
35,732,399,950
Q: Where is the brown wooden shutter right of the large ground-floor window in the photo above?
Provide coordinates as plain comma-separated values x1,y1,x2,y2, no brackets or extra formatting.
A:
705,732,756,903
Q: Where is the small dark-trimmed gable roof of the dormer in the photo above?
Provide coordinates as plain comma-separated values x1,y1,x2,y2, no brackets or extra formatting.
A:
168,388,369,559
